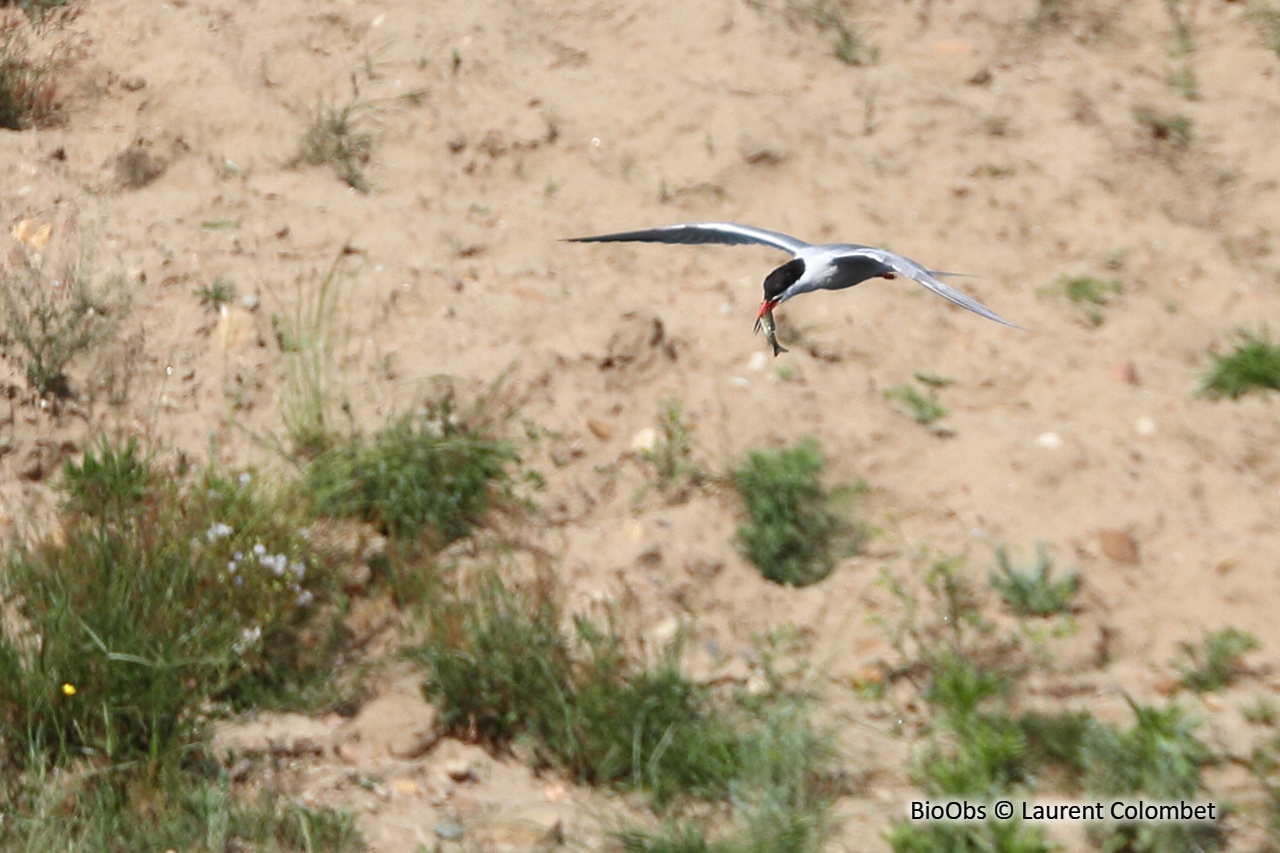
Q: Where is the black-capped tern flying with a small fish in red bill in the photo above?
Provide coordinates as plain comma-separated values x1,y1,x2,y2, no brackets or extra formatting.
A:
566,222,1021,350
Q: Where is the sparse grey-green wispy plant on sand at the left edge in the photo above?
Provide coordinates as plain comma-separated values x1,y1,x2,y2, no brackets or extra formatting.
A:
0,224,129,396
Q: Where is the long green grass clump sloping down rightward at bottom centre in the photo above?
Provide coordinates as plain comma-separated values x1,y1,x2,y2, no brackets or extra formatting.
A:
415,571,744,802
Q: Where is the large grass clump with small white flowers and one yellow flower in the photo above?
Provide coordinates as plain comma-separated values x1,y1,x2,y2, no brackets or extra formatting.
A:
0,442,348,765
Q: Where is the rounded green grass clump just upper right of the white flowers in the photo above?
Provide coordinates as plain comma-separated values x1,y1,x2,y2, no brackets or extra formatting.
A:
305,397,518,546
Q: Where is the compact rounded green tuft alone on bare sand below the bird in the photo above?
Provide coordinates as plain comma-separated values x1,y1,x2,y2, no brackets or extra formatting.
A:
733,439,860,587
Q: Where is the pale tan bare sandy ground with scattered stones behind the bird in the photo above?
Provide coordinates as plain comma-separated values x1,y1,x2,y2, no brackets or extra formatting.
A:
0,0,1280,850
